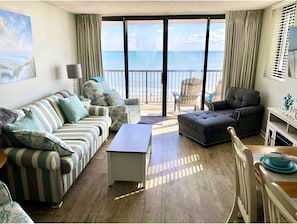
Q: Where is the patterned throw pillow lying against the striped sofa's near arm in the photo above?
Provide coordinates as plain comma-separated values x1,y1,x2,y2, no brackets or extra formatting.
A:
14,130,74,156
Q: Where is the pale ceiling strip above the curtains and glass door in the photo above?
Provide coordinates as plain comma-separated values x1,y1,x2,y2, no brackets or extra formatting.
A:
44,0,280,16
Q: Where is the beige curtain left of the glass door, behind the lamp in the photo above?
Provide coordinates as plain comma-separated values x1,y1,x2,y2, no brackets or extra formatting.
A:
76,14,103,92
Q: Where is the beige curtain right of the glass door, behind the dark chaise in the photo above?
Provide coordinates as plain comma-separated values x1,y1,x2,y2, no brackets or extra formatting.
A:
222,10,263,95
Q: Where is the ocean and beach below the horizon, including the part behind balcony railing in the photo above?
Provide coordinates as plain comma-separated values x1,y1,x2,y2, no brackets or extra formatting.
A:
102,51,224,102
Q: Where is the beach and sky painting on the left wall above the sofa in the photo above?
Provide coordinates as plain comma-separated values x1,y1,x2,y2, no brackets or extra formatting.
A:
0,9,36,84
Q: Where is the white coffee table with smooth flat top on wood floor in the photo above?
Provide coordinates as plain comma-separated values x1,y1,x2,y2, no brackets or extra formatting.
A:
106,124,152,187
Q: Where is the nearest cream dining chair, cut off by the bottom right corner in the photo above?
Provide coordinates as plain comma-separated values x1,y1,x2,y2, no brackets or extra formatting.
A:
255,162,297,223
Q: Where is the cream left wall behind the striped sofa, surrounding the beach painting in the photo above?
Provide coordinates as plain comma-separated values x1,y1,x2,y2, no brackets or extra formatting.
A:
0,1,77,109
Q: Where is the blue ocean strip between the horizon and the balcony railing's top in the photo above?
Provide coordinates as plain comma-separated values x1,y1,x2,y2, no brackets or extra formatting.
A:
102,51,224,70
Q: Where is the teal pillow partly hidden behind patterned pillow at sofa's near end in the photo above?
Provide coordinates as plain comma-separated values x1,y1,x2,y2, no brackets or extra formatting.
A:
3,110,41,147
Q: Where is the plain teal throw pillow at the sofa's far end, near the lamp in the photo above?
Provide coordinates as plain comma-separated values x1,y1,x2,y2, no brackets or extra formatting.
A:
59,95,89,123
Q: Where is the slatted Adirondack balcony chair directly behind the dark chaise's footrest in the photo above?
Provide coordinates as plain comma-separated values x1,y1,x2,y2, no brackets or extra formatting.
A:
172,78,202,111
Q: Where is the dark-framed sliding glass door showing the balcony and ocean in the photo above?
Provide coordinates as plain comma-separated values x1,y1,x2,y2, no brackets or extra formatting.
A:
101,15,225,116
